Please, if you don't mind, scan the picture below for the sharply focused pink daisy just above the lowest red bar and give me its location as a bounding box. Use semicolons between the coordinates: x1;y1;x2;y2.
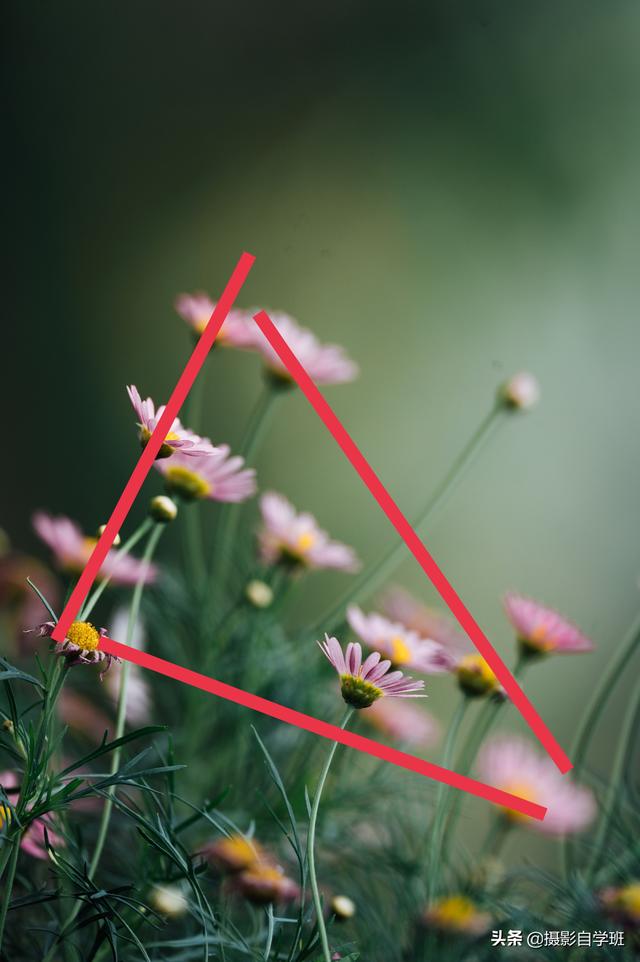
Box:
318;635;424;708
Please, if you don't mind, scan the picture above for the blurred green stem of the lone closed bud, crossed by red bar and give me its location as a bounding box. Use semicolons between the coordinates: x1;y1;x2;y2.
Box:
309;402;506;636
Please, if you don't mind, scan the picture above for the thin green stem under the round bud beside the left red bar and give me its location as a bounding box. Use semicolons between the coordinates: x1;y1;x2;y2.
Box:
50;524;165;948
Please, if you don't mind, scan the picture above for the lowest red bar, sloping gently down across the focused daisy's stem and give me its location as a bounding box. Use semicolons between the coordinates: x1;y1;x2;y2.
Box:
100;638;547;821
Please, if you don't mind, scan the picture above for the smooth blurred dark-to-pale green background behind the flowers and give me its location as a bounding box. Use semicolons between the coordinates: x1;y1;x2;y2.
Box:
5;0;640;852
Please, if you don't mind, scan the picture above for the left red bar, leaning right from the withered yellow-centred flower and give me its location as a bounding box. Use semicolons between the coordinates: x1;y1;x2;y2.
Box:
52;252;255;641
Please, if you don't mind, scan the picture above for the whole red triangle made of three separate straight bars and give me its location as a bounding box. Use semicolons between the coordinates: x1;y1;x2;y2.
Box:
52;252;572;820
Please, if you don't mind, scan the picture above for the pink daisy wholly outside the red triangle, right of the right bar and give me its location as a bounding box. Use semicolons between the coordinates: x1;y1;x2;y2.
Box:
504;593;594;655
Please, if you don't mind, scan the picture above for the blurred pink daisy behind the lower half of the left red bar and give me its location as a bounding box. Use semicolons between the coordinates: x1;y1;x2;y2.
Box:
33;511;158;585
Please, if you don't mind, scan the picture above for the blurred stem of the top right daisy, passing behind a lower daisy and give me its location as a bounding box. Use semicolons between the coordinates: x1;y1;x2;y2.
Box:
211;380;283;605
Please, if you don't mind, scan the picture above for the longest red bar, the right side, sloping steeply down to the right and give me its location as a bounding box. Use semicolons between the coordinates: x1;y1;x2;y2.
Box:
254;311;573;772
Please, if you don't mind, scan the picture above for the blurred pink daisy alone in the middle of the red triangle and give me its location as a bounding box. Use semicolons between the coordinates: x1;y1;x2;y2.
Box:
258;491;360;571
